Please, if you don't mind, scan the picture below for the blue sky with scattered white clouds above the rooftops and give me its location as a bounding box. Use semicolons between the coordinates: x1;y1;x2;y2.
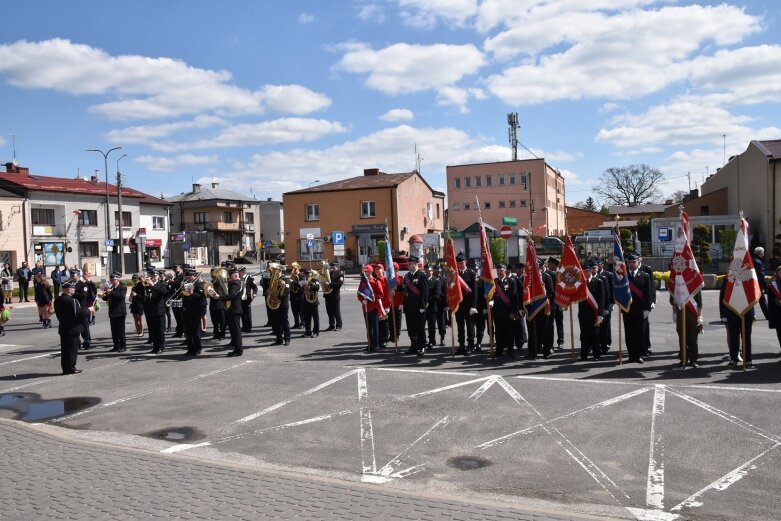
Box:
0;0;781;204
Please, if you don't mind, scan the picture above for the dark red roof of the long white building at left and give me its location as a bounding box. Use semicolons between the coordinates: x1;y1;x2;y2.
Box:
0;172;170;206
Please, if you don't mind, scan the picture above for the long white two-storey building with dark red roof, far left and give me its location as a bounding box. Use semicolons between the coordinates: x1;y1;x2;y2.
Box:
0;163;169;277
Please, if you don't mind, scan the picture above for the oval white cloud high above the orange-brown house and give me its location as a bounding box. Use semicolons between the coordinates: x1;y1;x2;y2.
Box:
335;43;485;95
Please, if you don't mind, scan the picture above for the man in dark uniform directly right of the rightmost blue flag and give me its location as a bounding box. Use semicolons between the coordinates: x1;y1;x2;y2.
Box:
621;253;653;364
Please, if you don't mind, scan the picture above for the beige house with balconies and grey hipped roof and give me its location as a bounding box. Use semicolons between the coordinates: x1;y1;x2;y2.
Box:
165;183;260;266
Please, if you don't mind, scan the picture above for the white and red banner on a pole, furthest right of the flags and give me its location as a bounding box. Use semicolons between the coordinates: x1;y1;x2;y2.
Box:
724;216;761;317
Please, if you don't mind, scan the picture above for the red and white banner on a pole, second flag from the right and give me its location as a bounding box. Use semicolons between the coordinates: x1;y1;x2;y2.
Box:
667;212;705;316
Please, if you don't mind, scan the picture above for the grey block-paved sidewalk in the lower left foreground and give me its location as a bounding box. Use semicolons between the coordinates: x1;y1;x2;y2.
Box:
0;419;620;521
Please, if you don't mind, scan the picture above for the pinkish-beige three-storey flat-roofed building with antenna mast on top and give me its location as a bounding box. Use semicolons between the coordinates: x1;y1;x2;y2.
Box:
447;159;567;236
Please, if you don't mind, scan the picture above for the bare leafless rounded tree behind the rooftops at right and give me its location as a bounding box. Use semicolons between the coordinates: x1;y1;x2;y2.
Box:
593;164;664;206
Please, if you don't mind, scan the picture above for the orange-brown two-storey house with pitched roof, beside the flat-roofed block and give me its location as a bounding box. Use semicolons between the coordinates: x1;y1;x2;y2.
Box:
282;168;445;267
